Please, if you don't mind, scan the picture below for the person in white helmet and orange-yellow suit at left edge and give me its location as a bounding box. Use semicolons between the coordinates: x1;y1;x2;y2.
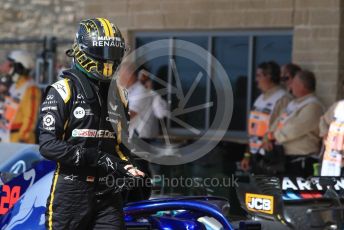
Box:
0;50;41;143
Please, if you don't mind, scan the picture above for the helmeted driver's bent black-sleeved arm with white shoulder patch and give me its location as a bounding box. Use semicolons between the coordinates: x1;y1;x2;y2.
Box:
39;80;98;166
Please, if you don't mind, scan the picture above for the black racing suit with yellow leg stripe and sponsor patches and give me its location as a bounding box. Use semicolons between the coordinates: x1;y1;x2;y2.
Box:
39;70;129;230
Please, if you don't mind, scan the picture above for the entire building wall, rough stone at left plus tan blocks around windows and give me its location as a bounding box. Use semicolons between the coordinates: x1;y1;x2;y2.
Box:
0;0;344;105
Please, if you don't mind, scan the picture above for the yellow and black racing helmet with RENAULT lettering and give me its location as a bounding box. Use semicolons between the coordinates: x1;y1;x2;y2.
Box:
67;18;126;81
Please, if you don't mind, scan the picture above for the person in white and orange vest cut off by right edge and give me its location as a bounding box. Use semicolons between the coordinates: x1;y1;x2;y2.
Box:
319;89;344;176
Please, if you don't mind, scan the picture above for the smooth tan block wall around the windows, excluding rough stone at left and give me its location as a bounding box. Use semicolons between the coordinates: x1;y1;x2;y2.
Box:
85;0;343;106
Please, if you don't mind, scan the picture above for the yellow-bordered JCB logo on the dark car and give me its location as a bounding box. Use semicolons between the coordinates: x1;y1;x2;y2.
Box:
245;193;274;214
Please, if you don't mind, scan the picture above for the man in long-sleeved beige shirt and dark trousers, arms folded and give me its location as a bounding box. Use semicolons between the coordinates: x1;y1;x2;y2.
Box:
266;70;323;177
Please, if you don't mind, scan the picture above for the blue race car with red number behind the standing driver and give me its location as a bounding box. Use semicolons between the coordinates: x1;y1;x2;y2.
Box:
0;145;260;230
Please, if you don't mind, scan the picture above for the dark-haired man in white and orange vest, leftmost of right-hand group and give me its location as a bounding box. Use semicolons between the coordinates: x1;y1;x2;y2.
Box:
241;61;290;171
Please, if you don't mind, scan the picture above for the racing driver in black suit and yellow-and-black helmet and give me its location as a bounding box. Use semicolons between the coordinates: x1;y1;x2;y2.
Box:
39;18;144;230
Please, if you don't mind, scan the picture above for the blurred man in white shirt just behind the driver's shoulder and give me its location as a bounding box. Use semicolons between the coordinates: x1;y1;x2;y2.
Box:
119;63;159;138
